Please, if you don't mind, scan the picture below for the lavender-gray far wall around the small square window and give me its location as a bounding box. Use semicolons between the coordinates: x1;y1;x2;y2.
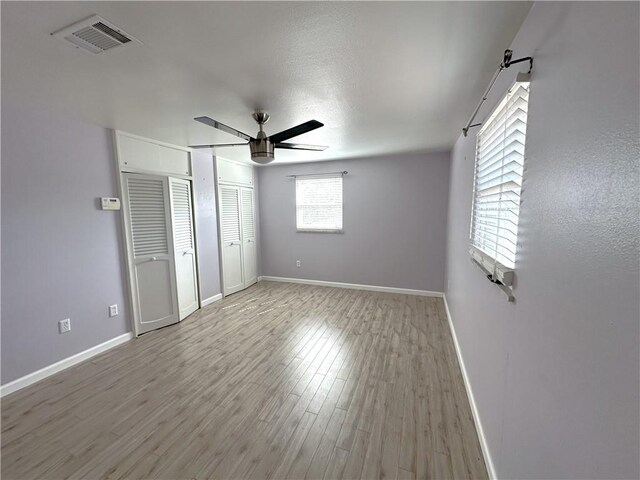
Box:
257;153;449;291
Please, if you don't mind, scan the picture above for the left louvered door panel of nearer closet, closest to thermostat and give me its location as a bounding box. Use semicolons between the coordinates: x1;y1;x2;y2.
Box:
123;174;178;335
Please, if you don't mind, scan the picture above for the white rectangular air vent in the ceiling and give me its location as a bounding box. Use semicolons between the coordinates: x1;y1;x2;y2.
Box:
51;15;141;53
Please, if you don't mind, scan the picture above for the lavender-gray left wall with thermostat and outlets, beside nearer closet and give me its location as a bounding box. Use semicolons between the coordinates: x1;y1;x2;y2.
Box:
1;100;131;384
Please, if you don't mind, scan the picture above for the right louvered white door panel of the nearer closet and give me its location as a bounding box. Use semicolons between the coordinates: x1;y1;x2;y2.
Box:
169;177;199;320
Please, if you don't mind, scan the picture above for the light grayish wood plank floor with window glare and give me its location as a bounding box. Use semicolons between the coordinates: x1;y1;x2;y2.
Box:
2;282;487;479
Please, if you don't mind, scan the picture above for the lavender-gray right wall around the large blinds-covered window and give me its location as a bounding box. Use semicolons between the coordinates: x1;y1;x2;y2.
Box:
446;2;640;479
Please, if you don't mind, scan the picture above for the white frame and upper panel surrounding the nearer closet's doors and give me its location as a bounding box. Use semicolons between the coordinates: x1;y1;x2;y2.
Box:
112;130;202;337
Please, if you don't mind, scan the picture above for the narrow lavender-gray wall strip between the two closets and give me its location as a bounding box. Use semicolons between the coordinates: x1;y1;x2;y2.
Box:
191;151;222;300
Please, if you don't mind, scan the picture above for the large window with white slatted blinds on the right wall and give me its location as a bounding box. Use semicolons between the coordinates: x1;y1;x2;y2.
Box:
471;82;529;272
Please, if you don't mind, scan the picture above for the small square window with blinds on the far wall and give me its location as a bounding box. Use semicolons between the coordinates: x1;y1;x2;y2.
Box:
296;174;342;232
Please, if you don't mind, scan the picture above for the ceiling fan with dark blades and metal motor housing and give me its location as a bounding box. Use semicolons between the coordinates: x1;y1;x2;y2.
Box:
191;111;327;164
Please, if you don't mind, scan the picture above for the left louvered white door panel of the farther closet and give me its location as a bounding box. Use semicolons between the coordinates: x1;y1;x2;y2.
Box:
219;185;244;295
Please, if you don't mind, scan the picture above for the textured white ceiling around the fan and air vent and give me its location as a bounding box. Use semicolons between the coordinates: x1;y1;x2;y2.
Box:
2;2;532;163
